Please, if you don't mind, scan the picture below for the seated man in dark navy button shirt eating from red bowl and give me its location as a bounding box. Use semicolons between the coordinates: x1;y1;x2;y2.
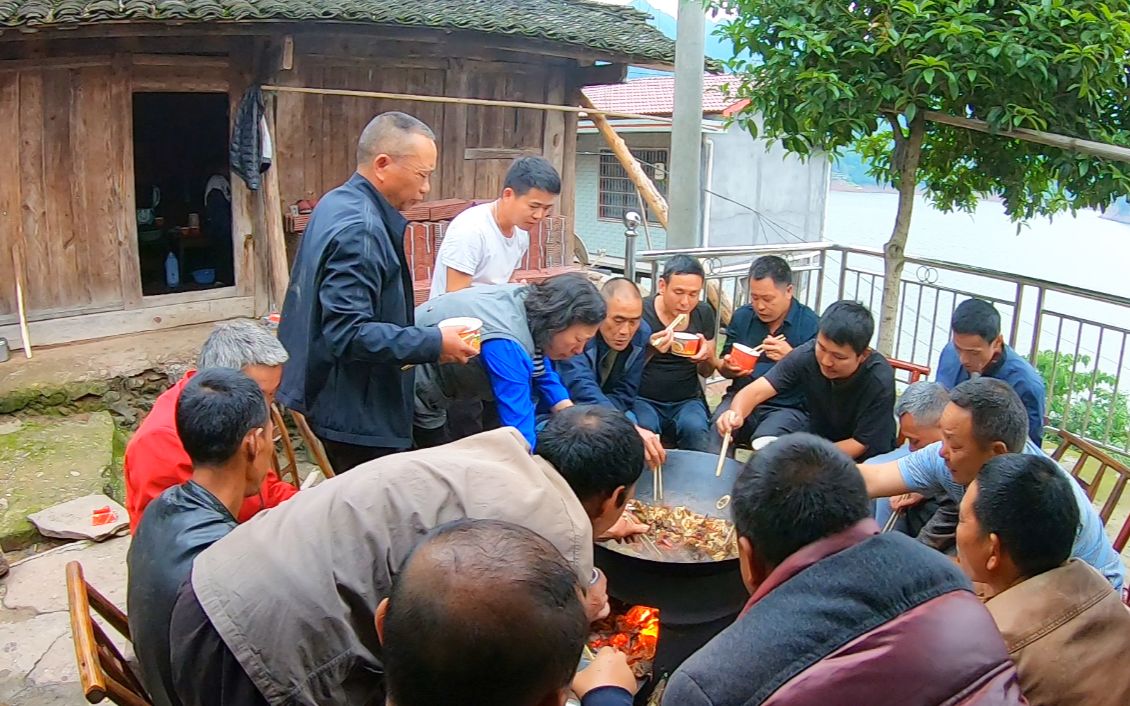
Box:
711;255;820;444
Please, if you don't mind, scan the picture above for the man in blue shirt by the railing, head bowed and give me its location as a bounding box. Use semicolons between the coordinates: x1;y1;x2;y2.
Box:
937;299;1046;445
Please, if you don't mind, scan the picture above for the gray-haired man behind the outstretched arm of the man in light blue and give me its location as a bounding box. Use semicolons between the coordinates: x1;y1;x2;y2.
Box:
868;381;957;552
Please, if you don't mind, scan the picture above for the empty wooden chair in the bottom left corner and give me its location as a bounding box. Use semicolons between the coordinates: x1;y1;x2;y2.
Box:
67;561;153;706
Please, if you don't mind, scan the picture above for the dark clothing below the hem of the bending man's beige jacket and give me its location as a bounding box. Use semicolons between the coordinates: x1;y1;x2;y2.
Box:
168;574;268;706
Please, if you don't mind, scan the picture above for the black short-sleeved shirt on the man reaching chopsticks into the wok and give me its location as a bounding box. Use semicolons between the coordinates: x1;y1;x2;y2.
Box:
765;340;897;459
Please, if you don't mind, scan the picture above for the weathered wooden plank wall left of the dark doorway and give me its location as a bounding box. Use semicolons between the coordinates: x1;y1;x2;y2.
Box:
0;59;133;322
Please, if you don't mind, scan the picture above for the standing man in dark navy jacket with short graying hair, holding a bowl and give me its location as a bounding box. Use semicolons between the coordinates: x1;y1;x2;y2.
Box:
278;113;475;473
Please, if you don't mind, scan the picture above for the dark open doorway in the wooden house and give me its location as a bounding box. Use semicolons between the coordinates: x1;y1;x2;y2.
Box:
133;93;235;296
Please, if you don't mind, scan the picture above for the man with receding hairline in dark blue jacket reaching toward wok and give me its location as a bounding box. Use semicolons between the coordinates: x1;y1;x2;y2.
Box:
557;277;667;467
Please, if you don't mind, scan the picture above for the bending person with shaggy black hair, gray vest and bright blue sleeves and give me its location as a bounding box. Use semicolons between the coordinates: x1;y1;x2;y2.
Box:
414;273;606;448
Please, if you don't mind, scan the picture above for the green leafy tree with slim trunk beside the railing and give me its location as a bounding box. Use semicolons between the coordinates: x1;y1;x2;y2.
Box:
707;0;1130;354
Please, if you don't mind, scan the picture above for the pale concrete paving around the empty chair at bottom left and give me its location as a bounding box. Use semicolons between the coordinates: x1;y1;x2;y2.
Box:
0;538;130;706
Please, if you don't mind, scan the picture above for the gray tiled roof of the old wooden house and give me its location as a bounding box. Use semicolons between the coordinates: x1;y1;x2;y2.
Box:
0;0;675;64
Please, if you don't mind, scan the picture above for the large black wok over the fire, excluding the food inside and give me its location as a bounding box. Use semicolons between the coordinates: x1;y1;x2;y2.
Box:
596;451;749;692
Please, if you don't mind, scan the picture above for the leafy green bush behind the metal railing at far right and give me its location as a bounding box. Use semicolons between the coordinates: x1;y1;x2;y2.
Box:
1036;350;1130;448
